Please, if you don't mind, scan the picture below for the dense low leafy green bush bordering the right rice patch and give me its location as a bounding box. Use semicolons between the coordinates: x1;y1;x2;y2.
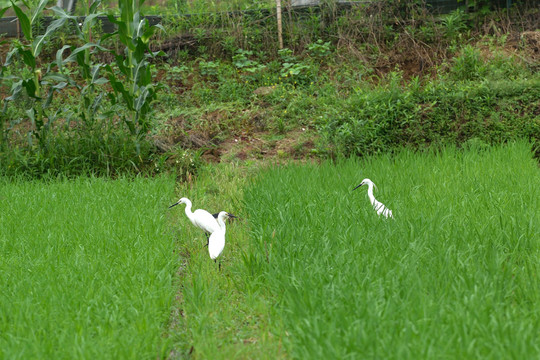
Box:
317;72;540;156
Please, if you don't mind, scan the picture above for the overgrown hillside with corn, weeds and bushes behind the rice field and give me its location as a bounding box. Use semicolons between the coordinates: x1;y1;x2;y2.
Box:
0;0;540;178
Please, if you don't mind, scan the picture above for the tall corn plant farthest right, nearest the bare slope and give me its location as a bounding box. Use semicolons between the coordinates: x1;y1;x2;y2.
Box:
105;0;164;139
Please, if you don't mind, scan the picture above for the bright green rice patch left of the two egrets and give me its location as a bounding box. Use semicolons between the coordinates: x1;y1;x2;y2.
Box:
0;177;177;359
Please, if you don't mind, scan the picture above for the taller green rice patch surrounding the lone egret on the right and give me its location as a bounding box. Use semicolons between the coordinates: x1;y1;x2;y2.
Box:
243;142;540;359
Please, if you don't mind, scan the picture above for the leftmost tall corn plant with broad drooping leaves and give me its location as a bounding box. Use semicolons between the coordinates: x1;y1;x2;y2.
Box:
0;0;68;149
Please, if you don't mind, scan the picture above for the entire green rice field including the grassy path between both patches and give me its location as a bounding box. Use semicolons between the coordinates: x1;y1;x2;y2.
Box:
0;142;540;359
